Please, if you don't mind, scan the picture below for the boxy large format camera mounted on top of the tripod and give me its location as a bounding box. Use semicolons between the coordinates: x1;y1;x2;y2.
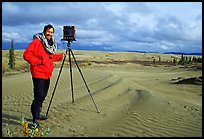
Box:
62;26;76;41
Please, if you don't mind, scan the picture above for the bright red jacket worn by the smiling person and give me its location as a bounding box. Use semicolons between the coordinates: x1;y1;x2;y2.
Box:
23;38;63;79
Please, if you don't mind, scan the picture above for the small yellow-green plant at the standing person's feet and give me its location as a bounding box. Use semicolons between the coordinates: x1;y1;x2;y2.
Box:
20;117;51;137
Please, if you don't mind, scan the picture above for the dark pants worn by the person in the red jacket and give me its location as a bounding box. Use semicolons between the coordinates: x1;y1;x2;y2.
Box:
31;77;50;121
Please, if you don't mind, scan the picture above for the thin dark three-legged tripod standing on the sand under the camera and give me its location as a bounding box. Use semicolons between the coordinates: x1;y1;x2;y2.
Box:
46;40;100;116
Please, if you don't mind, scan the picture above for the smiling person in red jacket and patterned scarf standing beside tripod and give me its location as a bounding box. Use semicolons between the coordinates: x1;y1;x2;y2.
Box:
23;24;65;128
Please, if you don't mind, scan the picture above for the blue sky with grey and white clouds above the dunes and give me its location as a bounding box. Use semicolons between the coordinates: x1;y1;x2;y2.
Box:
2;2;202;53
